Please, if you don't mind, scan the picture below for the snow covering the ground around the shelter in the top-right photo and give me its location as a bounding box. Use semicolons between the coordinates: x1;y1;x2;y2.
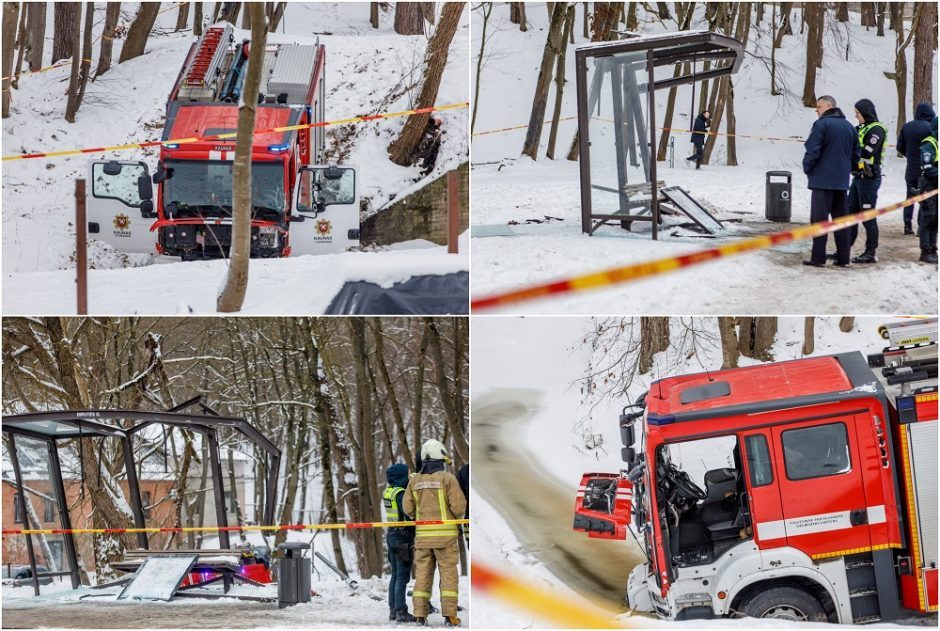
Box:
471;5;937;314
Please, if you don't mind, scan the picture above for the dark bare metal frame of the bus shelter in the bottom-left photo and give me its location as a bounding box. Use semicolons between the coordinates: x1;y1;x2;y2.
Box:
2;404;281;596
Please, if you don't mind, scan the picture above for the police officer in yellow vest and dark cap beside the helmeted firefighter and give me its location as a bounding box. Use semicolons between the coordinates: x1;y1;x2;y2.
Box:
382;463;415;622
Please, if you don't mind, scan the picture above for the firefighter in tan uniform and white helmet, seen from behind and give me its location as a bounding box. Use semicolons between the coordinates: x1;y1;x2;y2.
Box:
403;439;467;626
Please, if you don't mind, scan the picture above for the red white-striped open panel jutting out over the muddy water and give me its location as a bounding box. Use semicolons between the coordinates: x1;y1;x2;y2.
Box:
573;473;633;539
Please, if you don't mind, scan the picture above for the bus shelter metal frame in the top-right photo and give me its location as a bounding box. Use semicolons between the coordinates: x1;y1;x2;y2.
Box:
575;31;744;240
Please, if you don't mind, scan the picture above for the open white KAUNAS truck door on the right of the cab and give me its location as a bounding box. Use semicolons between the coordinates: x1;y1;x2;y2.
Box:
290;165;359;255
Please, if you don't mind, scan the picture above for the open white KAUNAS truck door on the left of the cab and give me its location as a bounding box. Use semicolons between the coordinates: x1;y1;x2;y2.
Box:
85;160;157;254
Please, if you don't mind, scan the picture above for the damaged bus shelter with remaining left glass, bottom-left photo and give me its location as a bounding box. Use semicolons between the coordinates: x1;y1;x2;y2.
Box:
2;404;281;596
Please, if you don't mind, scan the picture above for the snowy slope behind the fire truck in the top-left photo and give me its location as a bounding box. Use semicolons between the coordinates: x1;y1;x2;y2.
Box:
2;3;469;311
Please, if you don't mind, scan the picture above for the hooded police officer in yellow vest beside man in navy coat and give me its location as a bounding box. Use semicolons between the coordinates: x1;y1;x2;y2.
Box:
849;99;888;263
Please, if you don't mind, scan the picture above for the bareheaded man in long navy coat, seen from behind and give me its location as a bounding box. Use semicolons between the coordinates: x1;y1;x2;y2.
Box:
803;95;861;267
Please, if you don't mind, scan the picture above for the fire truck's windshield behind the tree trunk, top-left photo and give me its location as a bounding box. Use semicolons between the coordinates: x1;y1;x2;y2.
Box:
163;160;287;219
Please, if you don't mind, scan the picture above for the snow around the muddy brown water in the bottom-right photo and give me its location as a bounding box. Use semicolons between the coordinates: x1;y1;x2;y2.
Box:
470;317;936;629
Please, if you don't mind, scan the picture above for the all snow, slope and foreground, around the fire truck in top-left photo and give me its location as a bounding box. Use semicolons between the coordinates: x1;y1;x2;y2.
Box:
2;2;470;313
